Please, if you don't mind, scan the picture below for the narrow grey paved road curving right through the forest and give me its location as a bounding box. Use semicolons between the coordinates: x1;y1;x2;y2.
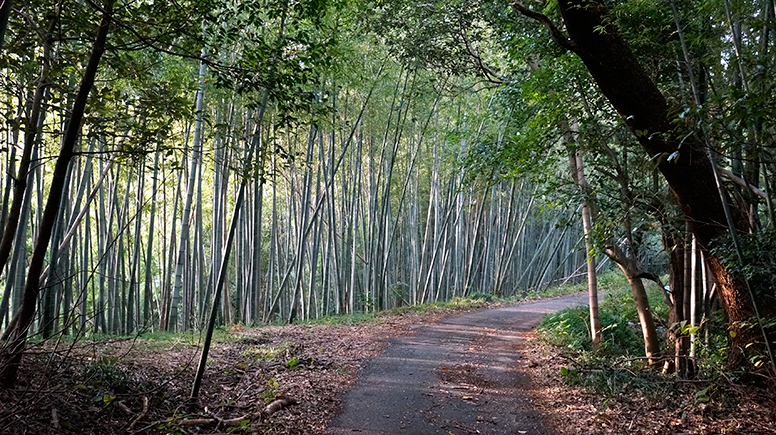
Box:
329;294;587;435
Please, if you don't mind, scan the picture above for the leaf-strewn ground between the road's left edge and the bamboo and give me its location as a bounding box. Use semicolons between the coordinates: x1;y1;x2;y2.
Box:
0;309;451;434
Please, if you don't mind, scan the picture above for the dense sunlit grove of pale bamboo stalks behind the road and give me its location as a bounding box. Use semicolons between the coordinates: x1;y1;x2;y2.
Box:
0;0;584;346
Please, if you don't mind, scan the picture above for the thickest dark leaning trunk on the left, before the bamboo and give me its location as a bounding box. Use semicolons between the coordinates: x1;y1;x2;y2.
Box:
0;3;112;387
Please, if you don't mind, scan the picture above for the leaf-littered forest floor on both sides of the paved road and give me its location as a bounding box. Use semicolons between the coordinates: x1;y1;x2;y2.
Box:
0;296;776;435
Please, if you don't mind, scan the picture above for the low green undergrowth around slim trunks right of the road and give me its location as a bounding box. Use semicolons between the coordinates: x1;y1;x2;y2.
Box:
537;272;744;402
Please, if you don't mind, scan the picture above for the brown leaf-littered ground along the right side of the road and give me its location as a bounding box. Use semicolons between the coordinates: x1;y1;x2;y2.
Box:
524;333;776;435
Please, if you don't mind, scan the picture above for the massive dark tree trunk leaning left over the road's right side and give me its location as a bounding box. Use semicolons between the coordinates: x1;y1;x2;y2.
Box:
515;0;776;366
